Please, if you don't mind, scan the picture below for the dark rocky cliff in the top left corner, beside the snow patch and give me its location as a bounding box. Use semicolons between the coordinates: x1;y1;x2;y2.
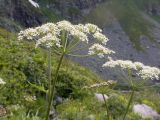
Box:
0;0;45;29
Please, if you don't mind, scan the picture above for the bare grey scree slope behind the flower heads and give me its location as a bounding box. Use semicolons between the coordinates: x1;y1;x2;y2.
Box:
72;19;160;80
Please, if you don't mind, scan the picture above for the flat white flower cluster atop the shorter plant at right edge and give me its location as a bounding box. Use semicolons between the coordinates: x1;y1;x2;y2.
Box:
103;60;160;80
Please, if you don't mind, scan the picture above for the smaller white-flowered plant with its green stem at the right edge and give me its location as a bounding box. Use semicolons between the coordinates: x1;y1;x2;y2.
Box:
102;59;160;120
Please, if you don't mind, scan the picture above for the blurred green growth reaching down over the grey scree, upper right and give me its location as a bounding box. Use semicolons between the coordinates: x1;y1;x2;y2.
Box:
85;0;158;50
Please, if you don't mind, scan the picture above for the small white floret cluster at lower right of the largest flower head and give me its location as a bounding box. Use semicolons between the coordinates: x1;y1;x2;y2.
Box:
88;43;115;58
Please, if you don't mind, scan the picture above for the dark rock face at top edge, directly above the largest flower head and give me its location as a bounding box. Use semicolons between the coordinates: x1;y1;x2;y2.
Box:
43;0;104;22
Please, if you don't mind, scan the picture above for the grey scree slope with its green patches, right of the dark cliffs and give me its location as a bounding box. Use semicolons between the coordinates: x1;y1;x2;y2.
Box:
73;0;160;79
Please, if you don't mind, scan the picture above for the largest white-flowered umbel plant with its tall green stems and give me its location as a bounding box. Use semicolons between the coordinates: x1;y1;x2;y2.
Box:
18;21;114;120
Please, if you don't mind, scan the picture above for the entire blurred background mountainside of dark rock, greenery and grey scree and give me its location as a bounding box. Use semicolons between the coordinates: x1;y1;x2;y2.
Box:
0;0;160;79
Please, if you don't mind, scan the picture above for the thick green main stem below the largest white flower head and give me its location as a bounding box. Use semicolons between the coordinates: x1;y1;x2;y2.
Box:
46;52;65;120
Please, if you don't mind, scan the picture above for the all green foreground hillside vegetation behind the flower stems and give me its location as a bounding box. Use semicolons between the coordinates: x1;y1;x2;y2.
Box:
0;25;160;120
